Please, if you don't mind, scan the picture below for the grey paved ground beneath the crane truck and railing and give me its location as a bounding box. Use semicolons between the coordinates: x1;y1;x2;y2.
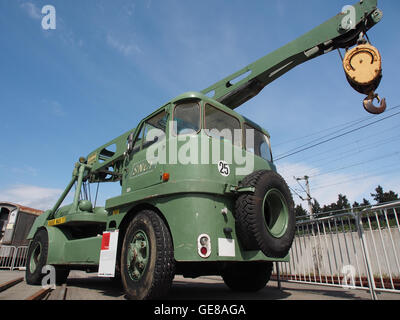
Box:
0;270;400;300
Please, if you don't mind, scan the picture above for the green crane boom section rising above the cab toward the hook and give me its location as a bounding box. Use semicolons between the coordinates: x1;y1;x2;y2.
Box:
202;0;382;109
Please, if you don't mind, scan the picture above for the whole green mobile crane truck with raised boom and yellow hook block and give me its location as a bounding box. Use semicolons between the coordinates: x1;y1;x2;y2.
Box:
26;0;386;299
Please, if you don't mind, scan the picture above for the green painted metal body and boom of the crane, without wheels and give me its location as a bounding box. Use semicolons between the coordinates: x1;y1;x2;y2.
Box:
28;0;381;266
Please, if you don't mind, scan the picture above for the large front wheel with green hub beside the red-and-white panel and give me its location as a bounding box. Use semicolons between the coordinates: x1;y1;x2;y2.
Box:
121;210;175;300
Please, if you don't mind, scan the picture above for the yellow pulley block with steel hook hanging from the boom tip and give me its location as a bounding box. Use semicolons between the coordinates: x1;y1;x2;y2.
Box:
343;41;386;114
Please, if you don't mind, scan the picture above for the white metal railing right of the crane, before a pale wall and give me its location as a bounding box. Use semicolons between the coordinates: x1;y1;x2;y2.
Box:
274;201;400;299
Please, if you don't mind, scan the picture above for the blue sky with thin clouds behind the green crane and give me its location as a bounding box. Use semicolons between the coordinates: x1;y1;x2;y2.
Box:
0;0;400;209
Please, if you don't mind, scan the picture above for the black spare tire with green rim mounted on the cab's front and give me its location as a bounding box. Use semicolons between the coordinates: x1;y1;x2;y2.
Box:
235;170;296;258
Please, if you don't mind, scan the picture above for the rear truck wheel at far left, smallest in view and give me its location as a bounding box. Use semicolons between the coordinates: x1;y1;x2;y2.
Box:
25;230;49;285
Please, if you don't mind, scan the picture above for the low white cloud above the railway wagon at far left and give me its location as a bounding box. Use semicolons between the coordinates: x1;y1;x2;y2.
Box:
0;185;63;210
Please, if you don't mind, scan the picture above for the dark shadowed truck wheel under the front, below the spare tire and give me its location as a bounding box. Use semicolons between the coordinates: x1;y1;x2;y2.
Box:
222;262;272;292
